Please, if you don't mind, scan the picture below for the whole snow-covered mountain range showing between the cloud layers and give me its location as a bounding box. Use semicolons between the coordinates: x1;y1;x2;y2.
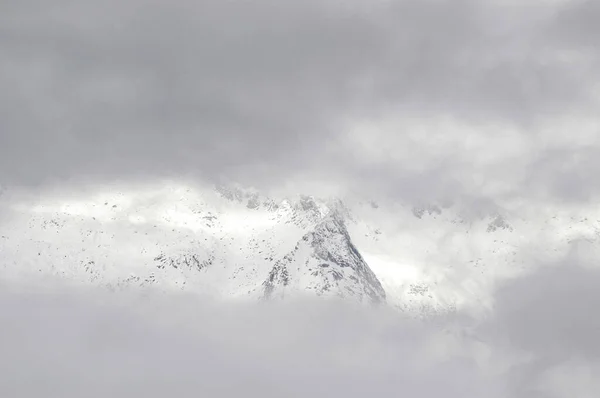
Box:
0;183;600;313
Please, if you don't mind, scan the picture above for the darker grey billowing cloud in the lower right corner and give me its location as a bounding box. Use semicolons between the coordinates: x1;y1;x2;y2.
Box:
480;255;600;398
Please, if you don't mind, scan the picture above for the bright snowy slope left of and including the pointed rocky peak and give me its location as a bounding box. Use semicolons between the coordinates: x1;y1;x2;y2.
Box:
0;185;385;302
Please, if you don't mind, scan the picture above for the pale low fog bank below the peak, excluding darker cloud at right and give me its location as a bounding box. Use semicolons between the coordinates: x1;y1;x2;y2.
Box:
0;285;502;398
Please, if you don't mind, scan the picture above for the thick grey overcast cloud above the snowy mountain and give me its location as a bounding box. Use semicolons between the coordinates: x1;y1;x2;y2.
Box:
0;0;600;202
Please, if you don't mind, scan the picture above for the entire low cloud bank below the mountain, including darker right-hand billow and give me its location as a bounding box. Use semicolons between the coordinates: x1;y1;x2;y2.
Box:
0;258;600;398
